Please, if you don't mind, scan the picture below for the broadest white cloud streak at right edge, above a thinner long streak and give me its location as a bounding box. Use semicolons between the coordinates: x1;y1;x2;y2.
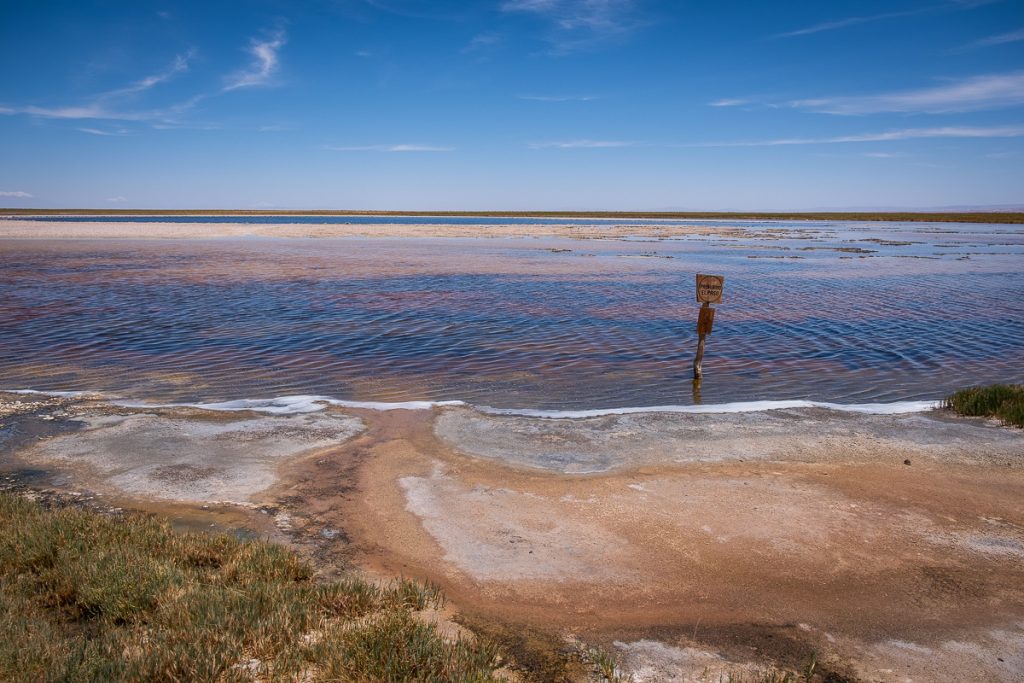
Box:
790;72;1024;116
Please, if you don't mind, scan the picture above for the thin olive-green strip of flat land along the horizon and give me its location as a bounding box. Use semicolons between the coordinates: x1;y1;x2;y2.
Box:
0;208;1024;223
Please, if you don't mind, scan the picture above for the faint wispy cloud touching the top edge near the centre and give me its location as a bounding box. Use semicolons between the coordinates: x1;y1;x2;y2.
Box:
501;0;643;54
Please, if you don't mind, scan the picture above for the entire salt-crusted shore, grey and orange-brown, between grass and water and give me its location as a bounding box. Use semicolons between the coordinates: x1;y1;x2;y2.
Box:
0;394;1024;681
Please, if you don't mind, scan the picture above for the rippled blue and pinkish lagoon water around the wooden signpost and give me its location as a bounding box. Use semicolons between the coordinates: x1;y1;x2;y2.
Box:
0;217;1024;410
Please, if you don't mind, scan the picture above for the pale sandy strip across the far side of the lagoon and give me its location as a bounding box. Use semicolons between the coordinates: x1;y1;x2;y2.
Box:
0;218;757;240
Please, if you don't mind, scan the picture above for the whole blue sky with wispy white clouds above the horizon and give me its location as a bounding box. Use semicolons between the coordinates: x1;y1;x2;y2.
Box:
0;0;1024;210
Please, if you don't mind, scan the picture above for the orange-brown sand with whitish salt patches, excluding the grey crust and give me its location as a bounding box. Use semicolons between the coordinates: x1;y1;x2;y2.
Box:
276;413;1024;681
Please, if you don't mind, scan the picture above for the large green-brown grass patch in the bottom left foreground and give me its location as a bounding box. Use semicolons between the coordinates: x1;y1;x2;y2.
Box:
0;495;497;681
